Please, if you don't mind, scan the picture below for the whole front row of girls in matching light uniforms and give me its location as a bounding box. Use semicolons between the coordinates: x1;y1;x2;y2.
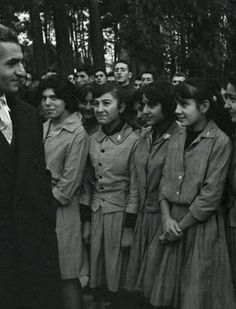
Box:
36;74;236;309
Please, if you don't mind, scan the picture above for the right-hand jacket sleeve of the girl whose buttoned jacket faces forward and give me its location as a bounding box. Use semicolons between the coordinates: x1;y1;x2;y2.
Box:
125;140;139;214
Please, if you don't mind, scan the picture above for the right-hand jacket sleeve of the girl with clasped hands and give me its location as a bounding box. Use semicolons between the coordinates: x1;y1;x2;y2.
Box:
189;136;232;221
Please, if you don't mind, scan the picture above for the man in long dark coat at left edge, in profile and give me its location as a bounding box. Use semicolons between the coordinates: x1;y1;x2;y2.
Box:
0;25;60;309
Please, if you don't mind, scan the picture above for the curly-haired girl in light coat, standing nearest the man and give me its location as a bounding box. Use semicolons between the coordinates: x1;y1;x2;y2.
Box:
39;76;88;309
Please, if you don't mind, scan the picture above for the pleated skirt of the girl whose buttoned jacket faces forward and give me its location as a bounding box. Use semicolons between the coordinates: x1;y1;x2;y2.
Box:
90;208;129;292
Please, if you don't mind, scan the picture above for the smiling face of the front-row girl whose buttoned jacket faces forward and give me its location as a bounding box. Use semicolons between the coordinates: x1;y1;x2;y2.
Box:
93;93;124;125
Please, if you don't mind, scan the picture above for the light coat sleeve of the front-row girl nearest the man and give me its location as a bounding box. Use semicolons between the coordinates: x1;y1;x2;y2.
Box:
53;132;89;205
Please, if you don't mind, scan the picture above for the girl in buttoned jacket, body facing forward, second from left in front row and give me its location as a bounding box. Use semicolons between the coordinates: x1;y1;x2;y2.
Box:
83;84;138;305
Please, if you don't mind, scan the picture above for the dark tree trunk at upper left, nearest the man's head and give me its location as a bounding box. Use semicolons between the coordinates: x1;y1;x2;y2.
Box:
30;0;46;76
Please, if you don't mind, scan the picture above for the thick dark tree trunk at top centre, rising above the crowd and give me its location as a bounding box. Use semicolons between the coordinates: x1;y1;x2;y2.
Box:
89;0;105;70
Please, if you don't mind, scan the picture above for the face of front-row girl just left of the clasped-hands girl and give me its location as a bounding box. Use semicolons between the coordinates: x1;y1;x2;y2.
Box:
142;94;165;126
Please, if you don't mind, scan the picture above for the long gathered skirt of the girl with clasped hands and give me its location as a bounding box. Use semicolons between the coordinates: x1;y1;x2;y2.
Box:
136;205;236;309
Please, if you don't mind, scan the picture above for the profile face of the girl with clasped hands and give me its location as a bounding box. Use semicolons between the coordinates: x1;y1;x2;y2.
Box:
175;99;203;127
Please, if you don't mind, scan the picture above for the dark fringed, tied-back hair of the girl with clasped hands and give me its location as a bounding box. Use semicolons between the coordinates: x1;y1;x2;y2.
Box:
173;78;232;135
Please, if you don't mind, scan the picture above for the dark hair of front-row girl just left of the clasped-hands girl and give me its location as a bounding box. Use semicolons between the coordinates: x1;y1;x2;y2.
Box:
140;81;176;120
